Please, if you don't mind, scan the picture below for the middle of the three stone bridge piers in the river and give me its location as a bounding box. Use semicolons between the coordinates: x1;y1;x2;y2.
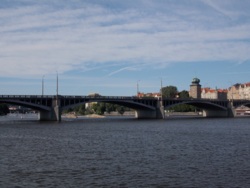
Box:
135;102;165;119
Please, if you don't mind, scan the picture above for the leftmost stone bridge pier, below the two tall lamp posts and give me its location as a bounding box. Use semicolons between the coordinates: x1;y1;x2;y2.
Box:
39;99;61;121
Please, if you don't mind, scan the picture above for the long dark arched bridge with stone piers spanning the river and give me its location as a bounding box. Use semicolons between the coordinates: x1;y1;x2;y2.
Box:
0;95;250;121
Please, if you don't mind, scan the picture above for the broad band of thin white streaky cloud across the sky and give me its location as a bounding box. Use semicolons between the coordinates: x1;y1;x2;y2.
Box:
0;0;250;77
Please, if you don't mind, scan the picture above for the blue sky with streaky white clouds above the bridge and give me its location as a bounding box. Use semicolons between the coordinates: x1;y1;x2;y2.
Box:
0;0;250;96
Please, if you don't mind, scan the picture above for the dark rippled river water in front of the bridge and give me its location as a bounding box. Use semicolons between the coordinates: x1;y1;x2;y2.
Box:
0;117;250;188
